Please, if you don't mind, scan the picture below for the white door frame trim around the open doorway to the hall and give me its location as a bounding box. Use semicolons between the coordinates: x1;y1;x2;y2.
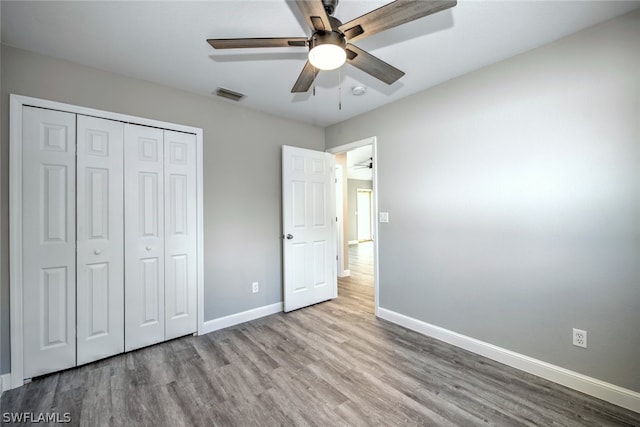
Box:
325;136;380;317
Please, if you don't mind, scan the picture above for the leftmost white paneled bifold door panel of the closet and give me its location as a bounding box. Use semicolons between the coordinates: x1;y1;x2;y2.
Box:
22;107;76;378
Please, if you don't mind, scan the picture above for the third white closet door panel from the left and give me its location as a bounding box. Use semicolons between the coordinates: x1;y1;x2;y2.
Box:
124;124;164;351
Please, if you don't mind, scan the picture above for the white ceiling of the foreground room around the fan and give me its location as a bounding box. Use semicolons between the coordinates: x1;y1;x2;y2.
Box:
2;0;640;126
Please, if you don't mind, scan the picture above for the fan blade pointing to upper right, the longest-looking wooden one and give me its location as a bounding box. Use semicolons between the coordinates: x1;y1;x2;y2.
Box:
340;0;457;42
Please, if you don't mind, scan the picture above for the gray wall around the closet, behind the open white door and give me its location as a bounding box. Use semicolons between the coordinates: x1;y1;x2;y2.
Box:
0;46;324;373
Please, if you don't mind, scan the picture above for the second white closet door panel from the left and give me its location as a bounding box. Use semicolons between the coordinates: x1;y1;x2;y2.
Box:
76;116;124;364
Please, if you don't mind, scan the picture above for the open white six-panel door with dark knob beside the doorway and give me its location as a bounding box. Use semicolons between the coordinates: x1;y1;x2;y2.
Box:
282;146;338;311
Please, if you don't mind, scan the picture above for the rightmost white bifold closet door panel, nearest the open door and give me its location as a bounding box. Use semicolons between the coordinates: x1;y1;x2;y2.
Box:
164;131;197;339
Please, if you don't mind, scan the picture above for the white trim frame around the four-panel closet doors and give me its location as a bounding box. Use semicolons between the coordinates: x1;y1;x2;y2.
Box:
9;94;206;388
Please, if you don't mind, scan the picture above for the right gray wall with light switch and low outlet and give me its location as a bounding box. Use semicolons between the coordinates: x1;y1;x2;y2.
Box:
326;11;640;391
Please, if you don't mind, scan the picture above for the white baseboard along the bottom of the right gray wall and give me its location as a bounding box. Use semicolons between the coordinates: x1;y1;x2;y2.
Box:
377;307;640;413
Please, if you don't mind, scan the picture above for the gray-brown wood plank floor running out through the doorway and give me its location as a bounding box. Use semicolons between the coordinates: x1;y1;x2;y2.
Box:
0;245;640;426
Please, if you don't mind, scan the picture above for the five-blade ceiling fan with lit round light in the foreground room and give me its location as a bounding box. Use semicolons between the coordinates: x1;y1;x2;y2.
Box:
207;0;457;93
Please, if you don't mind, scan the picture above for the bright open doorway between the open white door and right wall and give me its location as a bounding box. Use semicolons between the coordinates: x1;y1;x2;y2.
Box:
327;137;378;315
